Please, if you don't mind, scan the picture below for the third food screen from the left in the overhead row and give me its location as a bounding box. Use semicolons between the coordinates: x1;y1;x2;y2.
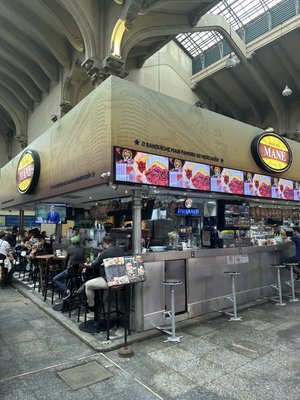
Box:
210;166;244;194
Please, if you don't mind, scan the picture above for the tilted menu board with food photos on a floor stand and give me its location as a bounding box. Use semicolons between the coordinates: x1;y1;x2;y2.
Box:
103;256;146;287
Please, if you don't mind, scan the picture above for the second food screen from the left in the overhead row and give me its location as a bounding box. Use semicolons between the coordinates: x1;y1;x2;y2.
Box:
169;158;210;191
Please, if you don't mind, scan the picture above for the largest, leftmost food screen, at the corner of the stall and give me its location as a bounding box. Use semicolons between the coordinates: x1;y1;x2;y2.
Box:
115;147;169;186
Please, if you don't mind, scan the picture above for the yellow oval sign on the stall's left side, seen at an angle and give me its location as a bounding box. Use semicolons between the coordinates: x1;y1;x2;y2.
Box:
16;150;40;194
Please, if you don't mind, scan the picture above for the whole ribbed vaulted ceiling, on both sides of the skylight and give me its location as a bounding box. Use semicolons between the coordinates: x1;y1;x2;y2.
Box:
0;0;300;159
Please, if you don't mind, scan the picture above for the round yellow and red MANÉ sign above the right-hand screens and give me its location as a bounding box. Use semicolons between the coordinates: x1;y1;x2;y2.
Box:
251;132;292;172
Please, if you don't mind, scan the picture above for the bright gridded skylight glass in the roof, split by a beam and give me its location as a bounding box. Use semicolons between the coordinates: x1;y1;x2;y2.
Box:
176;0;285;57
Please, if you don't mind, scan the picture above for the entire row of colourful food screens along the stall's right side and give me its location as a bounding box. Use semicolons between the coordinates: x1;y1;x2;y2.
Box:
114;147;300;201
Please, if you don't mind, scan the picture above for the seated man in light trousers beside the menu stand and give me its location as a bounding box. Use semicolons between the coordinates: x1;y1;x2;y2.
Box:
85;235;125;311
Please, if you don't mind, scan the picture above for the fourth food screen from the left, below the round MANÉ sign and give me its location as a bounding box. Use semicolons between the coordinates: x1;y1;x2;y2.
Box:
244;172;271;198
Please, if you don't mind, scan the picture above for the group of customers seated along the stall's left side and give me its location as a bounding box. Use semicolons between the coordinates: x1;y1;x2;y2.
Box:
0;227;125;310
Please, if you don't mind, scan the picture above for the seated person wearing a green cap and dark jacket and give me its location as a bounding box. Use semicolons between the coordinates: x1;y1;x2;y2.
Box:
53;236;85;300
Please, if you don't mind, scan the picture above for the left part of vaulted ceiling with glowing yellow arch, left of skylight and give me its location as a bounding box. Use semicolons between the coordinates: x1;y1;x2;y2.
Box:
0;0;215;152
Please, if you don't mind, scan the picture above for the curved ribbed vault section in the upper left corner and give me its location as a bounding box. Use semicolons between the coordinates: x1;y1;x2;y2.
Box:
0;0;84;148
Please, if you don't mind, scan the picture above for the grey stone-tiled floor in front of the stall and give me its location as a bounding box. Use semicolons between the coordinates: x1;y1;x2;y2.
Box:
0;276;300;400
